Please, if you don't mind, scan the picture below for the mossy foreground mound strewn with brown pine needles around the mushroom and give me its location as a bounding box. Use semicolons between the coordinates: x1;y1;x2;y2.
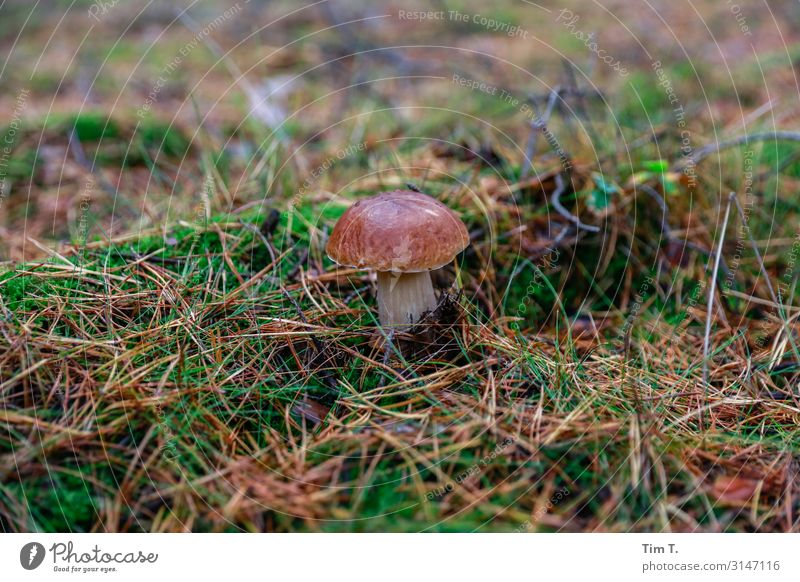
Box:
0;179;798;531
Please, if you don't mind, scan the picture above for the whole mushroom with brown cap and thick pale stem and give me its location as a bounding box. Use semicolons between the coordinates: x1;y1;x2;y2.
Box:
325;190;469;330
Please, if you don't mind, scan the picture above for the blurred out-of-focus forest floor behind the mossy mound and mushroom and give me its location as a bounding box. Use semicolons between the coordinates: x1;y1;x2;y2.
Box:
0;0;800;260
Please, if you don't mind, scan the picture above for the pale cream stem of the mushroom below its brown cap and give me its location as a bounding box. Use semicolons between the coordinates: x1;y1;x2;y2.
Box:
378;271;436;330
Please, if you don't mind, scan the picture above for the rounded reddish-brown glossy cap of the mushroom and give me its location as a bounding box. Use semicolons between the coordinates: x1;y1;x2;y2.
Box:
325;190;469;273
